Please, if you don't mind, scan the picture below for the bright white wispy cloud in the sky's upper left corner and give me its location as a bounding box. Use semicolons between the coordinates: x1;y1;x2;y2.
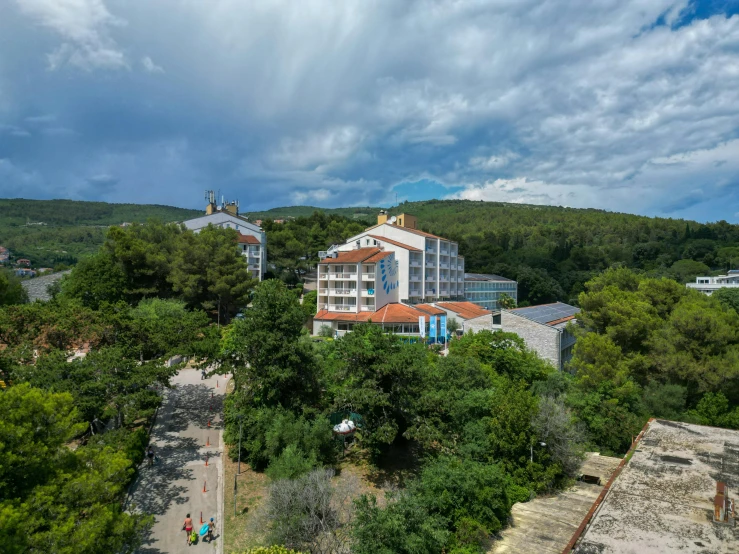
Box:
16;0;128;71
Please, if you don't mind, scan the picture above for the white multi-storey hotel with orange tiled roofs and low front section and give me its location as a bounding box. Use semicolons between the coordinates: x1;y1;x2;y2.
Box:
313;212;482;336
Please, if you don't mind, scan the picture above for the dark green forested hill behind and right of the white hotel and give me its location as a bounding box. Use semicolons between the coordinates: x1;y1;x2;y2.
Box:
262;200;739;304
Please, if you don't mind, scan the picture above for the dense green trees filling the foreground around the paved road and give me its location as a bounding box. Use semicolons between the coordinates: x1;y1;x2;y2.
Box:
0;214;739;554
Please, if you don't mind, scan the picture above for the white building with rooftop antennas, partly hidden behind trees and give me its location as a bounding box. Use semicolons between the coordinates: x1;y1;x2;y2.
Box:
182;191;267;281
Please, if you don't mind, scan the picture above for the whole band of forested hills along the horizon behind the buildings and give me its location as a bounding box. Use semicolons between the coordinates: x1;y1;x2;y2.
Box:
5;196;739;305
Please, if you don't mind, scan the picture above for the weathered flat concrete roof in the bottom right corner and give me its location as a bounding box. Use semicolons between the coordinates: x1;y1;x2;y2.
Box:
565;419;739;554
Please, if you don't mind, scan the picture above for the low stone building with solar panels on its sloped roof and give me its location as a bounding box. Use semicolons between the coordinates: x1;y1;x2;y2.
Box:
501;302;580;370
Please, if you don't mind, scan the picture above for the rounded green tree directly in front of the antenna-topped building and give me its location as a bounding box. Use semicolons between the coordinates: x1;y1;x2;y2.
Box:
169;225;257;323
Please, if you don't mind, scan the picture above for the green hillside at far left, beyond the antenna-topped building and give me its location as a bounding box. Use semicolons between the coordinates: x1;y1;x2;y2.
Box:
0;198;202;267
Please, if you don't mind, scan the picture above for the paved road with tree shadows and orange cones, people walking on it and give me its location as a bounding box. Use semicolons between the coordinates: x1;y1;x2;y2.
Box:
128;369;226;554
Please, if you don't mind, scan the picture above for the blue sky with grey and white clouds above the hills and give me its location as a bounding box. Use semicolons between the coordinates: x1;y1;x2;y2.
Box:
0;0;739;223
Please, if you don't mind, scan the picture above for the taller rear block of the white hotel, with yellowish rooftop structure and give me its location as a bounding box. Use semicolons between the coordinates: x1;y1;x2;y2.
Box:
334;212;464;304
